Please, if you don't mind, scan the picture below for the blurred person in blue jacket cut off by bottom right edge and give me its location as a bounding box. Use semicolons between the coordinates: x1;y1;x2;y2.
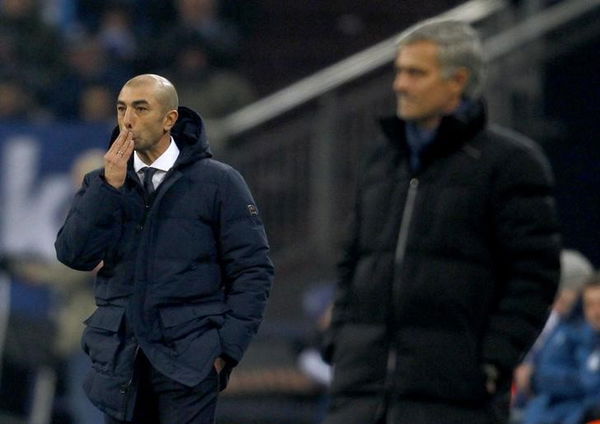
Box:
523;274;600;424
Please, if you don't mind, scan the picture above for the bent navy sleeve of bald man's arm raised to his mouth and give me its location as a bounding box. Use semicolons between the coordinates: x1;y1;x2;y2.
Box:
54;171;122;271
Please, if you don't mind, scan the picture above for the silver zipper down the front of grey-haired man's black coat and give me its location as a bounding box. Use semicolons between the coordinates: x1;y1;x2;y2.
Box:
377;177;419;422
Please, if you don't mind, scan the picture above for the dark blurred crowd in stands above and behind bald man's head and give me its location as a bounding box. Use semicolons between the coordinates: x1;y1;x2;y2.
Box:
0;0;257;122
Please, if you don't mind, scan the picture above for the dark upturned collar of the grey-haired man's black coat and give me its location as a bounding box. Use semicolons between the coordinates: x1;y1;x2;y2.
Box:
380;99;487;162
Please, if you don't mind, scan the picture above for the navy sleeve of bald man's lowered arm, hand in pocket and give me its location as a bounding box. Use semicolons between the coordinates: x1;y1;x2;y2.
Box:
218;169;273;365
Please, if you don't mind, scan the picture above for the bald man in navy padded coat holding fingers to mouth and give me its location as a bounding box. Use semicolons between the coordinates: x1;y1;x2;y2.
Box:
56;74;273;424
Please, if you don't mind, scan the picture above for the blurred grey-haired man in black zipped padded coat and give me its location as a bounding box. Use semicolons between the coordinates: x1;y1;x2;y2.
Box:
324;20;560;424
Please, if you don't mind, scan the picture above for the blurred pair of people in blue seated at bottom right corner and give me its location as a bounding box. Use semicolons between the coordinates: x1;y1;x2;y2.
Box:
511;249;600;424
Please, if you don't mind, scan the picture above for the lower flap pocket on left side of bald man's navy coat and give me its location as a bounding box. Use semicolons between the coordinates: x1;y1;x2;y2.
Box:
82;306;125;373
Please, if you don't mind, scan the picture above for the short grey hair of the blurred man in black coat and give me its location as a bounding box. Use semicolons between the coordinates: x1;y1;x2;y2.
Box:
396;18;485;99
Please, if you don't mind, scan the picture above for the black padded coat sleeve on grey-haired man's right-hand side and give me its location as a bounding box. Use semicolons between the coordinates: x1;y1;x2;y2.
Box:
482;142;560;378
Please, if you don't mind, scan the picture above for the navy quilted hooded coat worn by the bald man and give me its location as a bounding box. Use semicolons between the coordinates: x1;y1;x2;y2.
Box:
55;107;273;420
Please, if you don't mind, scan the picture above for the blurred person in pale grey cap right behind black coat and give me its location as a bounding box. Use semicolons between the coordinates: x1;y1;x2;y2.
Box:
511;249;593;421
